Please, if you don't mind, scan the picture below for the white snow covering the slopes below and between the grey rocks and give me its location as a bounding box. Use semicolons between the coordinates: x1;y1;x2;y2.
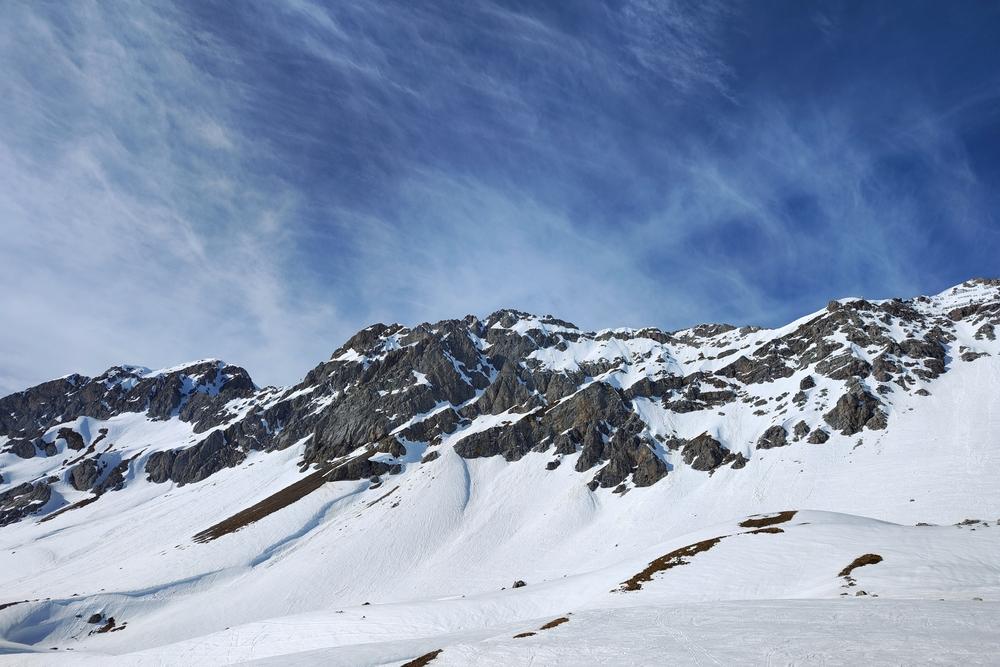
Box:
0;285;1000;667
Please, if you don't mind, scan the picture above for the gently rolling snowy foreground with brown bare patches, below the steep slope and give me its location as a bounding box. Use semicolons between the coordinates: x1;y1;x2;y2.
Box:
0;511;1000;665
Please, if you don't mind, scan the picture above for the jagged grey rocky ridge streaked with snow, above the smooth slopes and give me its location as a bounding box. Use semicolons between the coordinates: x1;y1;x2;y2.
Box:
0;279;1000;524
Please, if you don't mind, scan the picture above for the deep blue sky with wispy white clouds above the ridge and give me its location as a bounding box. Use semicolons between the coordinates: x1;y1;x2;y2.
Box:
0;0;1000;394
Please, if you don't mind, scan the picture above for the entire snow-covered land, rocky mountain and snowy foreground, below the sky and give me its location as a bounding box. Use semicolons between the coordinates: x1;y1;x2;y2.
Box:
0;279;1000;665
